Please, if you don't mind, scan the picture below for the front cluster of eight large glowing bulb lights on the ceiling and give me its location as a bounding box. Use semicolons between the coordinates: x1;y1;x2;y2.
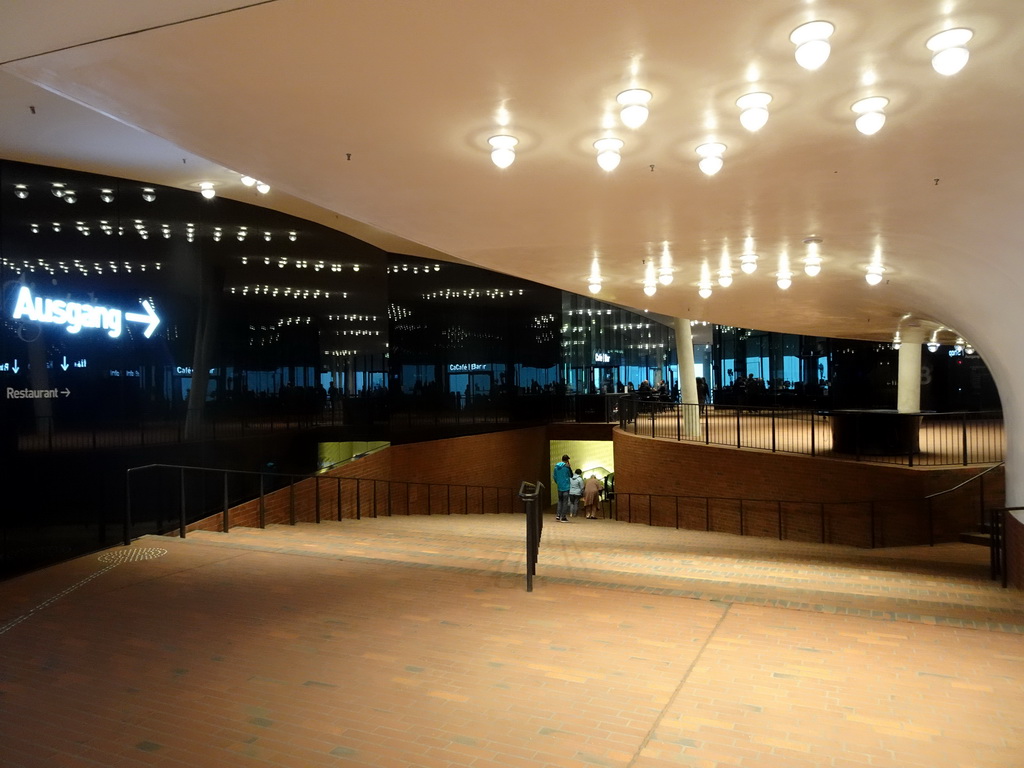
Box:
487;20;974;176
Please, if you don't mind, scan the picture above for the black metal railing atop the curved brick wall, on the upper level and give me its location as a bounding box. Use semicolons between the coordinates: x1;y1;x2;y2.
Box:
618;397;1006;467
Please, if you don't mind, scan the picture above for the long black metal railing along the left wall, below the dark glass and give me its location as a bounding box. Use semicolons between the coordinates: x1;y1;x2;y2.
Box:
123;464;515;544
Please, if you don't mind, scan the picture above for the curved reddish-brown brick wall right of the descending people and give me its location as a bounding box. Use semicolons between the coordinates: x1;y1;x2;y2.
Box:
613;429;1005;547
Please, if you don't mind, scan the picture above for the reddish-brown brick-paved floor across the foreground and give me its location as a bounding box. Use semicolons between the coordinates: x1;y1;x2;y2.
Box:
0;515;1024;768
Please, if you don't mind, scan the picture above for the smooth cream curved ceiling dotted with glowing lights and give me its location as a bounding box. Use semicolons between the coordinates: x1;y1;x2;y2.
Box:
0;0;1024;348
